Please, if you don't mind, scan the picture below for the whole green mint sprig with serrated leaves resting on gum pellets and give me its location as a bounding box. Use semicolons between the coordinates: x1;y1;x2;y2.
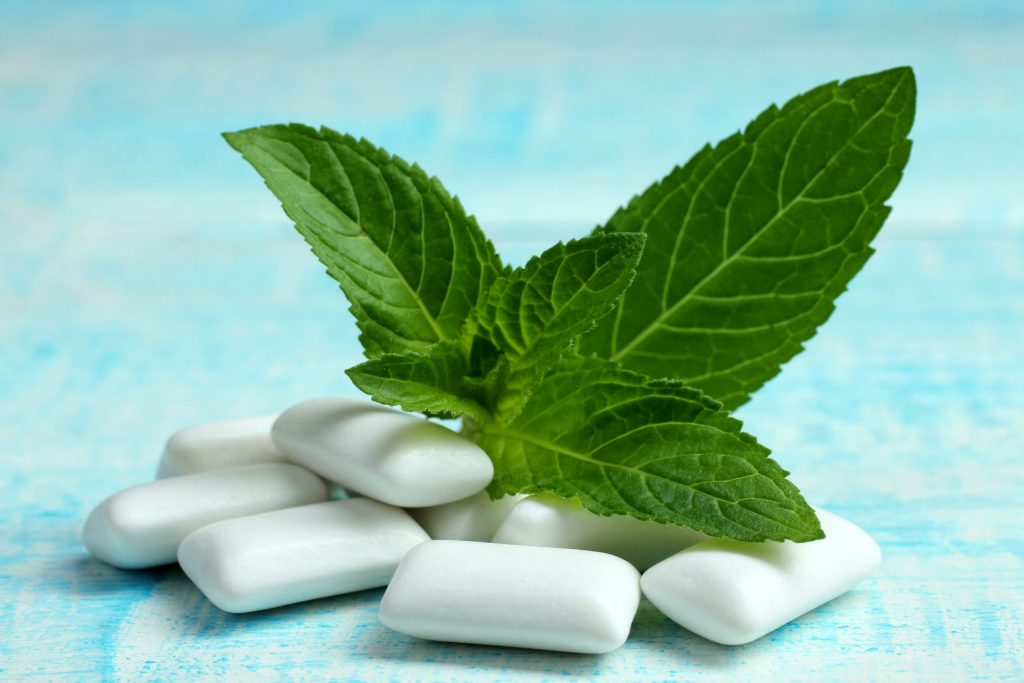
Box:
225;68;915;542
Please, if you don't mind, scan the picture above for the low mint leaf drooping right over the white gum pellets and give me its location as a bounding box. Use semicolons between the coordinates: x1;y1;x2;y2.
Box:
477;357;823;542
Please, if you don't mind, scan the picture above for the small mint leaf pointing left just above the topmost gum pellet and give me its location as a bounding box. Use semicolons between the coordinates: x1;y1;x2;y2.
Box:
345;341;489;422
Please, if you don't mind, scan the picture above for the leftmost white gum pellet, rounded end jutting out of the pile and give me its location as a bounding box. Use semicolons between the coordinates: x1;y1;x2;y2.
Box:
82;463;328;569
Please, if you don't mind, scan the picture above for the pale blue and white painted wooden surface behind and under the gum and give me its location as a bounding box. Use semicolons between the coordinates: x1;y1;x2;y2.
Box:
0;2;1024;681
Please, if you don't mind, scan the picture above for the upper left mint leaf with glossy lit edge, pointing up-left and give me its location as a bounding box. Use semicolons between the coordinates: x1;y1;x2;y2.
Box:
224;124;502;357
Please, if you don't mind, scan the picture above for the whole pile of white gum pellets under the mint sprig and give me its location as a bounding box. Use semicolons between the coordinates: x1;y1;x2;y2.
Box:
82;398;881;653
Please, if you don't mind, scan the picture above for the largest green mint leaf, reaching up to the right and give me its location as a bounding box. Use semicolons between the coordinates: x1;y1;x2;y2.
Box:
581;68;915;410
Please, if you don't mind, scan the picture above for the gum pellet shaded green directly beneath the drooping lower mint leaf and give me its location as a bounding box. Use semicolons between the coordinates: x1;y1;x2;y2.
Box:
494;495;708;571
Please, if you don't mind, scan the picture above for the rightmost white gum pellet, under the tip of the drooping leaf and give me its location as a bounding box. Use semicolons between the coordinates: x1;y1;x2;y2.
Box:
641;510;882;645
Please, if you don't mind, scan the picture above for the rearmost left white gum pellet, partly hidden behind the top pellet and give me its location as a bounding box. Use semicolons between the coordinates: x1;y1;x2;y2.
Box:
157;415;285;479
